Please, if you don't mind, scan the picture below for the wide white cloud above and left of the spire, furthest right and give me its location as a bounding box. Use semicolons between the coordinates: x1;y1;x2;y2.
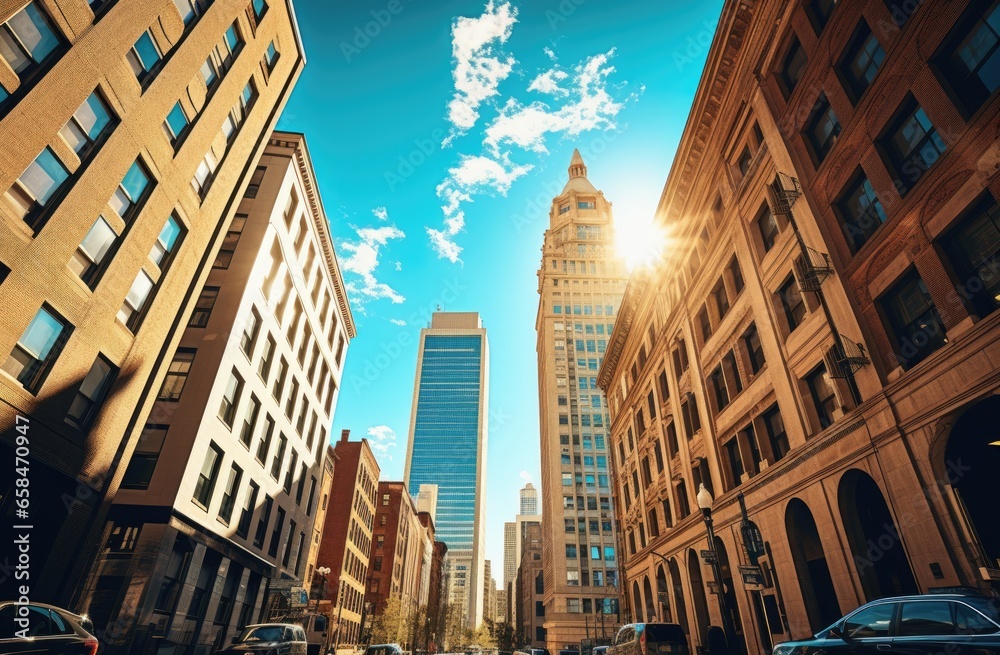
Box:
483;49;626;153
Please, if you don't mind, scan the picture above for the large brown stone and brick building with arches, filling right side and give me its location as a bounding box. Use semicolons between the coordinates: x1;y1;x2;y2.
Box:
600;0;1000;653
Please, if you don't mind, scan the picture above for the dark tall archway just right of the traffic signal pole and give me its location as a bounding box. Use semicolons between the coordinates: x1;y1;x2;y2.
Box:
785;498;842;633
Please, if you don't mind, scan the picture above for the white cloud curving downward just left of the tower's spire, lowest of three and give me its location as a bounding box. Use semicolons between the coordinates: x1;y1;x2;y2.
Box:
427;153;532;264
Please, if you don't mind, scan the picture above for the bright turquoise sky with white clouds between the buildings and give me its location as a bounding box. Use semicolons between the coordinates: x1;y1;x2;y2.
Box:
278;0;722;581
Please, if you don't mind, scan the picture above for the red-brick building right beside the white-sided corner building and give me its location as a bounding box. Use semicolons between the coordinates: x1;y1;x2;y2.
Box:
313;430;380;645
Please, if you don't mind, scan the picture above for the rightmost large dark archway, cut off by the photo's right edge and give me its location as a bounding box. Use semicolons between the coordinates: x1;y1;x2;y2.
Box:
939;396;1000;568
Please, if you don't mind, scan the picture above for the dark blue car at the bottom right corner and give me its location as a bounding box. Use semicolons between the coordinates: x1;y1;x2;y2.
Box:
772;592;1000;655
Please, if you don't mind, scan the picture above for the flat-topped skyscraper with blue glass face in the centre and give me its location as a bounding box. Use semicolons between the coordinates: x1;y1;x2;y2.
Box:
404;312;489;629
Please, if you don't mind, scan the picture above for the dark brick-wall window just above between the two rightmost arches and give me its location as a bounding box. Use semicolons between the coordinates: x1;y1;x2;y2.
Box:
881;270;948;370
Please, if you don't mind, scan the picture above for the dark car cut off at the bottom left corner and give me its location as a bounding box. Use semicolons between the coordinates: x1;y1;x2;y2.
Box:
0;601;99;655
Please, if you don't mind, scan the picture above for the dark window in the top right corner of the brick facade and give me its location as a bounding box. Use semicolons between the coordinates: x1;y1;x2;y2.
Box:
936;0;1000;117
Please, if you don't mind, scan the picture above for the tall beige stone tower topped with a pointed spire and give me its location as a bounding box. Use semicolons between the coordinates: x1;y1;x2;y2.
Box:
526;150;627;652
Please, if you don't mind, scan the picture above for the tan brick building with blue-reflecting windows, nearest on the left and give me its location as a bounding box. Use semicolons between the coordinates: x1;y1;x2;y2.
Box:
0;0;304;609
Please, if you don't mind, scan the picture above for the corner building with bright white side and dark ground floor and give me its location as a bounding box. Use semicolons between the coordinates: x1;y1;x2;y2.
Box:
81;132;354;651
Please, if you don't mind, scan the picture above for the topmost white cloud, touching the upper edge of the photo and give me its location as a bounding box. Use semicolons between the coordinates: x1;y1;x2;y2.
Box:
446;0;517;137
